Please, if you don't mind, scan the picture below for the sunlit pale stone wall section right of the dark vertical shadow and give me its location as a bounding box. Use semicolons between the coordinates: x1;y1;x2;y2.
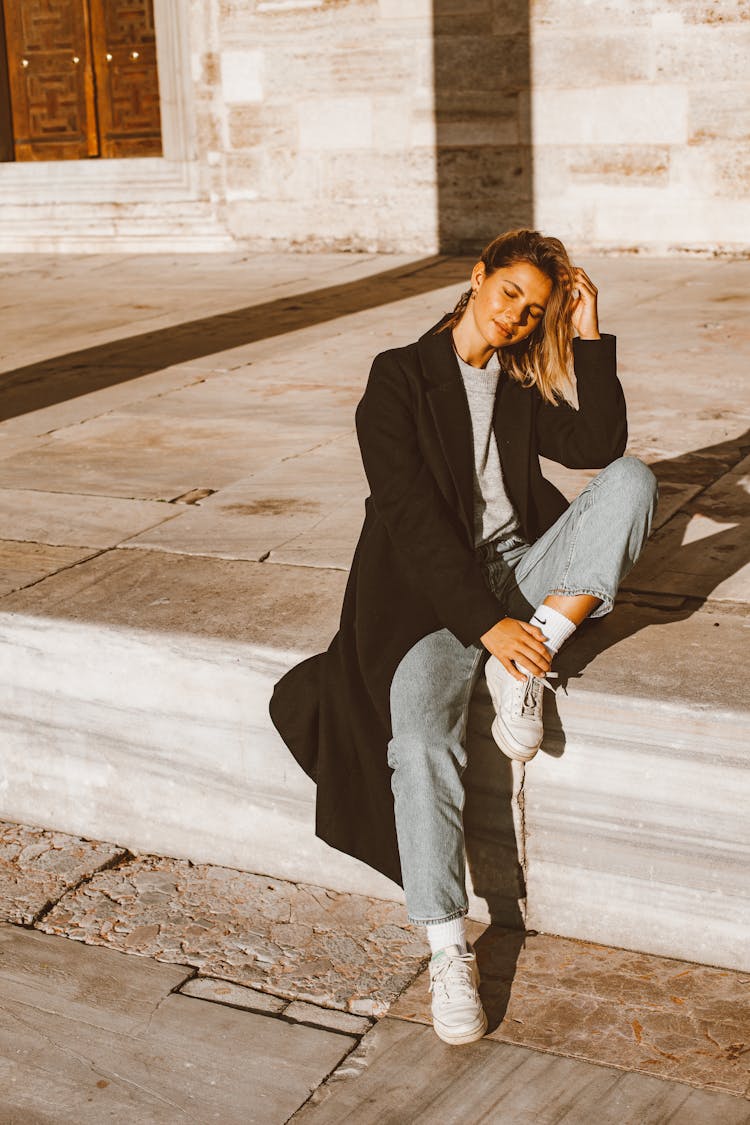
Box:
530;0;750;253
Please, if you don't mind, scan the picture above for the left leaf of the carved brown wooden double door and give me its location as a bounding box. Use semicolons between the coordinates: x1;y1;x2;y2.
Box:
4;0;99;160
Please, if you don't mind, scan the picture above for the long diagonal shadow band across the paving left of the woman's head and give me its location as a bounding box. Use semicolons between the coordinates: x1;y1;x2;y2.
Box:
0;255;466;421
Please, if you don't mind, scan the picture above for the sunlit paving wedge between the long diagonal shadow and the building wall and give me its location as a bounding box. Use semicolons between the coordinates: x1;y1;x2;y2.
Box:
0;252;416;370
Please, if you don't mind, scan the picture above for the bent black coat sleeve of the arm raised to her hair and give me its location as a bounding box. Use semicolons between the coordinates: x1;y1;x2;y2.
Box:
536;335;627;469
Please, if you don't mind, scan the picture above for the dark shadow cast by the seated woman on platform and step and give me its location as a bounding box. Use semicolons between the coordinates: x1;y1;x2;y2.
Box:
464;431;750;1031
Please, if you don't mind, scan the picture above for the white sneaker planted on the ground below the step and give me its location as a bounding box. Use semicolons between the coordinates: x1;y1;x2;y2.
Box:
430;945;487;1045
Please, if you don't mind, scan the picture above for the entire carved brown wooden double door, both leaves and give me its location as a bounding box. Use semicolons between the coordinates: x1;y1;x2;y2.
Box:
0;0;162;160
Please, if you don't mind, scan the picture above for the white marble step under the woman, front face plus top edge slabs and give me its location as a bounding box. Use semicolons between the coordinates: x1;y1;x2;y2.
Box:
0;549;750;970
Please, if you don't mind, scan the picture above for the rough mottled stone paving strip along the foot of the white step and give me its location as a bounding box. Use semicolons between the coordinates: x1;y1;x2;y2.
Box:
0;824;750;1102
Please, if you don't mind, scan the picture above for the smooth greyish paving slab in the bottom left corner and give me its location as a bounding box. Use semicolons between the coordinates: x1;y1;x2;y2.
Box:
0;927;356;1125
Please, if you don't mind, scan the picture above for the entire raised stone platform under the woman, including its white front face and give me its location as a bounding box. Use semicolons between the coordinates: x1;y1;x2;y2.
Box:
0;254;750;968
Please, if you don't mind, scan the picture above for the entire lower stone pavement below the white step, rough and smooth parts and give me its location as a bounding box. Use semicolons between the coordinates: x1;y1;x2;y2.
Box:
0;824;750;1125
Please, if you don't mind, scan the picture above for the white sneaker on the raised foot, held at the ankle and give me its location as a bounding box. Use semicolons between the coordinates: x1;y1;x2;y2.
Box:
485;656;554;762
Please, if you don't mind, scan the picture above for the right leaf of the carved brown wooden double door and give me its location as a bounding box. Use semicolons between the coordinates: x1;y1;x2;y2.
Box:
90;0;162;156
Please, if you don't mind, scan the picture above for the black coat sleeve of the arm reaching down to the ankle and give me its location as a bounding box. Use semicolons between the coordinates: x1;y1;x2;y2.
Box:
355;353;503;646
